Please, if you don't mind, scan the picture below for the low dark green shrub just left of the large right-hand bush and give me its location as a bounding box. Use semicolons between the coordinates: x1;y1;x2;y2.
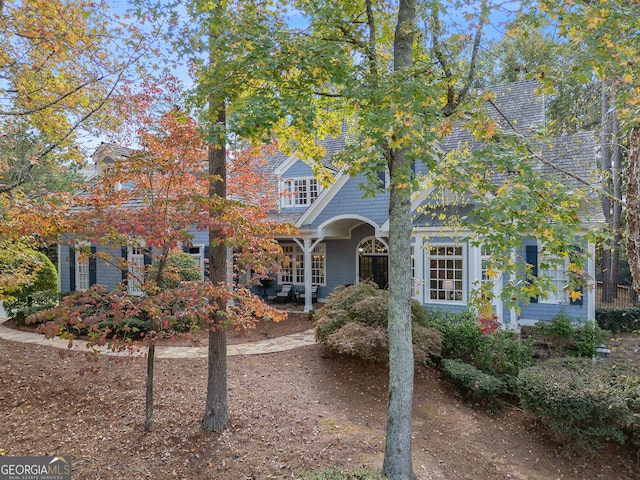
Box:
442;358;505;409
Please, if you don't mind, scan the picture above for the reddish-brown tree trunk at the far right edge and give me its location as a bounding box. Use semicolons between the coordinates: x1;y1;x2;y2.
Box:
627;125;640;300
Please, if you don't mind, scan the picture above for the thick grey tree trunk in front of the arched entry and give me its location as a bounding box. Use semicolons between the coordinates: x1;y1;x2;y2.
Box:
382;0;416;480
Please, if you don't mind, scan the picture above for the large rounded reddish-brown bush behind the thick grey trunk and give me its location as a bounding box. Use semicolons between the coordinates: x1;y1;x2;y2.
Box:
316;282;441;364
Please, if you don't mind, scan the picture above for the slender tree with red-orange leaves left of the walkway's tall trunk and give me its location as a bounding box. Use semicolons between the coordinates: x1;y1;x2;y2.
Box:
28;80;286;430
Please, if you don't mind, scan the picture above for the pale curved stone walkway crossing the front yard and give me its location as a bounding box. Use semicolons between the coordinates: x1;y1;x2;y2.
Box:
0;319;316;358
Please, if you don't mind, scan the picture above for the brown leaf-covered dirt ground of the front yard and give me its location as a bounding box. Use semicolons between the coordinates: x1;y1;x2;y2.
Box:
0;308;640;480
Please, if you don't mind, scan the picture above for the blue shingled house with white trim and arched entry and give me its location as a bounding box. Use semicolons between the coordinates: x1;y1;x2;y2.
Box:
59;81;602;327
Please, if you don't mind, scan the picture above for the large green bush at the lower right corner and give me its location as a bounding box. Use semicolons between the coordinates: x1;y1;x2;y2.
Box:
517;358;640;455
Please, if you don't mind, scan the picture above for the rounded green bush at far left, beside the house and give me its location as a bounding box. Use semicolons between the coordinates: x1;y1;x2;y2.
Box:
4;250;58;322
